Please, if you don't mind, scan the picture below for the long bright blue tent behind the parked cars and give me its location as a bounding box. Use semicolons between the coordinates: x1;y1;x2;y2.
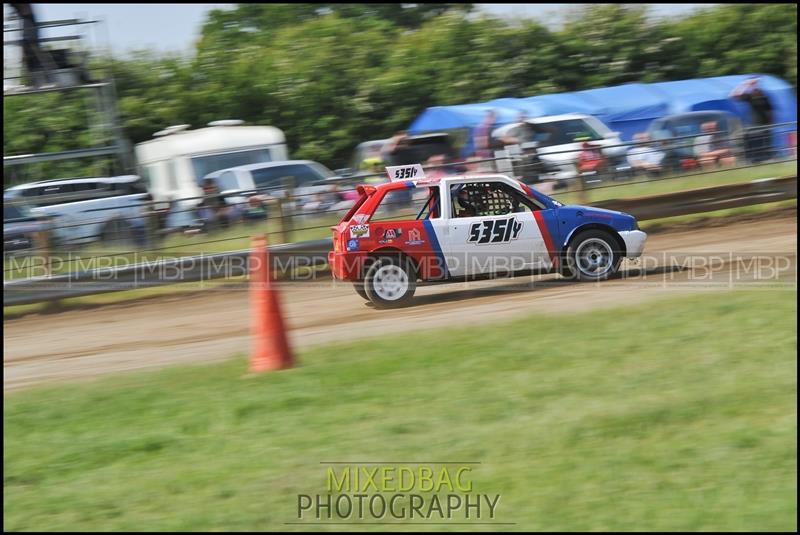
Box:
408;74;797;154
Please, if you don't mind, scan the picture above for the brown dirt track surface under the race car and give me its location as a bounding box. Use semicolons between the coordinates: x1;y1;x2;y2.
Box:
3;216;797;390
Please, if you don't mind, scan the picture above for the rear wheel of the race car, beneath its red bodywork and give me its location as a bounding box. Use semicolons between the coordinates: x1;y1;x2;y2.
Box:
364;257;417;308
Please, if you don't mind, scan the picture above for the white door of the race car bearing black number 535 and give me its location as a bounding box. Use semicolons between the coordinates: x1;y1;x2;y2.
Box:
437;180;550;277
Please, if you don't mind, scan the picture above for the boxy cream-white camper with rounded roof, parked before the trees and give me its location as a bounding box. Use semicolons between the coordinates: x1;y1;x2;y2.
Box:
135;120;289;204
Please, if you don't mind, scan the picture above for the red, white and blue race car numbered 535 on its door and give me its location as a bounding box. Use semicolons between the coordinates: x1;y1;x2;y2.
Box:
328;164;647;308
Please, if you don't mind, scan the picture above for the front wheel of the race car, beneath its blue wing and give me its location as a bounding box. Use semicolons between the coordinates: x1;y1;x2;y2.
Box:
562;229;622;281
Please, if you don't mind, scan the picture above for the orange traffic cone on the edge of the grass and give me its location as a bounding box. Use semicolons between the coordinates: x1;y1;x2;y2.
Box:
250;236;294;373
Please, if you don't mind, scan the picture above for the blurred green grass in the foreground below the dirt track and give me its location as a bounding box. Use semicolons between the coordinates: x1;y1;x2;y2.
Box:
3;290;797;531
